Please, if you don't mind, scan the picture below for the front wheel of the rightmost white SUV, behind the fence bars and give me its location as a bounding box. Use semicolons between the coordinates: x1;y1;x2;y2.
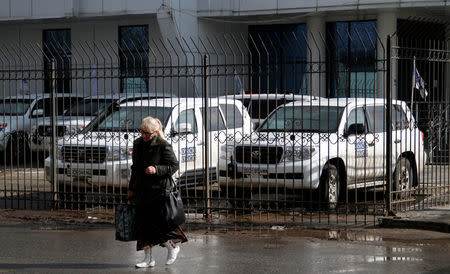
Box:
319;164;340;209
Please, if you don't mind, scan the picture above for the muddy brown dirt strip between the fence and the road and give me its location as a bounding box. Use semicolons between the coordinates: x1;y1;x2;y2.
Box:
0;209;450;244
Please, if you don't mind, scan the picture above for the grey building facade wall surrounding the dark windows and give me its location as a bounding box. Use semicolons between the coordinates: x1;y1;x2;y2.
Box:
0;0;444;97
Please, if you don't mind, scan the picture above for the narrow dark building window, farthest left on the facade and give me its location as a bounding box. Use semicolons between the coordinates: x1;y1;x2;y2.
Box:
42;29;72;93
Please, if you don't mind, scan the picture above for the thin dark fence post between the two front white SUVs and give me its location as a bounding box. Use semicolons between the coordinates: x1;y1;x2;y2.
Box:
203;55;211;219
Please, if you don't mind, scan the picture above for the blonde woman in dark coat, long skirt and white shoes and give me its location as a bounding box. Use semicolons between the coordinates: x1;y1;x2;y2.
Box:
128;117;187;268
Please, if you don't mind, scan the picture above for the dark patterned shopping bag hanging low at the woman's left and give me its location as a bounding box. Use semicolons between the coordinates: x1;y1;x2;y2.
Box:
115;204;136;242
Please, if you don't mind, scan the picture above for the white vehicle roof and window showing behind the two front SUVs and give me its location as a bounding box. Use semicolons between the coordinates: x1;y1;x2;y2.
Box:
224;93;318;129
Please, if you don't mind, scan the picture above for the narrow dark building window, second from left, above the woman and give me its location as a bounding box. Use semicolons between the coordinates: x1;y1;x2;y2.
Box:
119;26;149;93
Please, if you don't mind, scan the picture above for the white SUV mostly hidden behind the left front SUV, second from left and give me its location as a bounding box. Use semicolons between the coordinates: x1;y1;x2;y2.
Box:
30;93;167;152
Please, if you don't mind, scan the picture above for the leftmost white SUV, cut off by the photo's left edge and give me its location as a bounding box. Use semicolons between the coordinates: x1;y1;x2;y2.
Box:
0;93;83;162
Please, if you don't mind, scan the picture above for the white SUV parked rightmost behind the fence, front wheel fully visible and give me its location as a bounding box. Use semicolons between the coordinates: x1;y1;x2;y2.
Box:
218;98;426;207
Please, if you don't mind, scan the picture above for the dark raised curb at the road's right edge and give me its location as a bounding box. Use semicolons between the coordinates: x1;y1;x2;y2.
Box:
379;217;450;233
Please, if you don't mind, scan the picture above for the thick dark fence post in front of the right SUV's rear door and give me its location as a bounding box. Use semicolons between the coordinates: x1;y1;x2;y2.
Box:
385;35;392;214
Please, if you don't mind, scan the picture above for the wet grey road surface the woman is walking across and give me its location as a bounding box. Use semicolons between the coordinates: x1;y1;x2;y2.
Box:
0;223;450;273
